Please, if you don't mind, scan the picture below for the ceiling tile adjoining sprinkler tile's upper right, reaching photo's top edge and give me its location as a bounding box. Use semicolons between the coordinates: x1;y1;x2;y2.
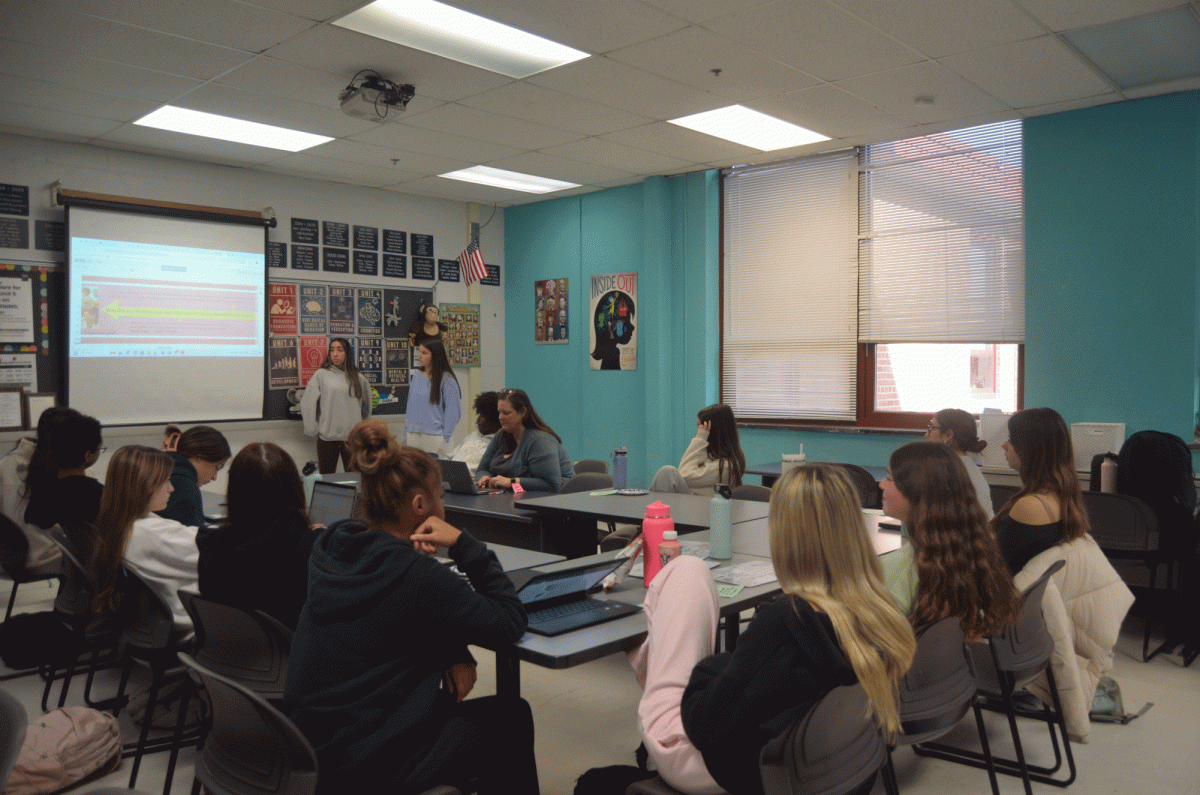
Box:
704;2;923;80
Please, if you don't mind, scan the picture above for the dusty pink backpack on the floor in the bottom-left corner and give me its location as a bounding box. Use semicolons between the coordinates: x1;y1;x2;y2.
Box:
4;706;121;795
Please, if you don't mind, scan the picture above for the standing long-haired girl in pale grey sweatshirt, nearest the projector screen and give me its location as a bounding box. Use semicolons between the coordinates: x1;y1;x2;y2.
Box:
300;336;371;474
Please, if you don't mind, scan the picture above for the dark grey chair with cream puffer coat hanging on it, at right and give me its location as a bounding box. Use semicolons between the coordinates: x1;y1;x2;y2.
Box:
913;561;1075;795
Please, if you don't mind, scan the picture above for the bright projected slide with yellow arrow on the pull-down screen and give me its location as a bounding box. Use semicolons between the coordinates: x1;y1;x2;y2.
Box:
70;238;264;358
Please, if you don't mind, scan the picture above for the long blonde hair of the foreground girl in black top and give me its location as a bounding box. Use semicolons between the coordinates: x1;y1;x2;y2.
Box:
768;464;917;741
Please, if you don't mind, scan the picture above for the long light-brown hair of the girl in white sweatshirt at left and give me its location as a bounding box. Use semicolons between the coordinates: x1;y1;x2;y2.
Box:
92;444;175;614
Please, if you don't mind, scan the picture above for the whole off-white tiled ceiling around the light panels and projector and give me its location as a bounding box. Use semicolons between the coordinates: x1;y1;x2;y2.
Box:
0;0;1200;205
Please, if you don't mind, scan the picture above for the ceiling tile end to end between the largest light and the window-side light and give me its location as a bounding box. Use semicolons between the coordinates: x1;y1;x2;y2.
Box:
526;58;727;120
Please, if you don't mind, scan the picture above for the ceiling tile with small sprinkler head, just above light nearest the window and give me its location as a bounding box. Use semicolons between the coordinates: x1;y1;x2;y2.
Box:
608;26;818;102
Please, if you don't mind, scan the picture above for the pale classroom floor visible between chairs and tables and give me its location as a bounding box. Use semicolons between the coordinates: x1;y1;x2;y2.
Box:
0;582;1200;795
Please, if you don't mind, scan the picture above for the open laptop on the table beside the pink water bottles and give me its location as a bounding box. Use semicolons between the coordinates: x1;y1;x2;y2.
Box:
510;557;642;635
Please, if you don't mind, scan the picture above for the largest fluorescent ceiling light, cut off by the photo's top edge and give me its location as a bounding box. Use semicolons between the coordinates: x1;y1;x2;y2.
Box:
334;0;588;79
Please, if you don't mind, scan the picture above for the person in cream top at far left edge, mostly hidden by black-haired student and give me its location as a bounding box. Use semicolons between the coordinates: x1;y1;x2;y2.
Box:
0;406;71;574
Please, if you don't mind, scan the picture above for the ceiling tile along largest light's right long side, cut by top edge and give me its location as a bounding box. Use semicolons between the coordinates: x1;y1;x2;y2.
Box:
450;0;686;55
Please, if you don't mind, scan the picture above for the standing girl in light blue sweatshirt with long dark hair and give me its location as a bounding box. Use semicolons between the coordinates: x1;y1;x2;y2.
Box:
402;340;462;456
